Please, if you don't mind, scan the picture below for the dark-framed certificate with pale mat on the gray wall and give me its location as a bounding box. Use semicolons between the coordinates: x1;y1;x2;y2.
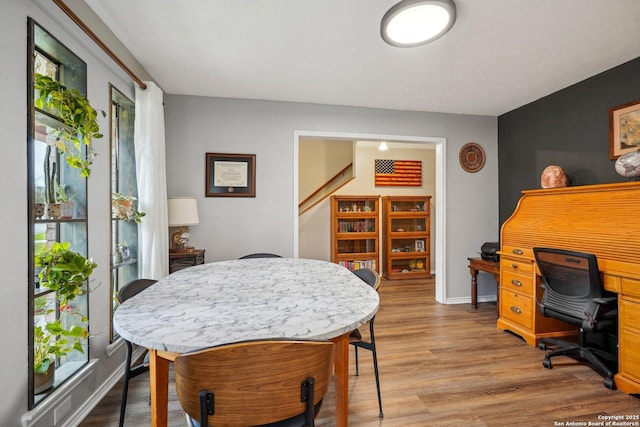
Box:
205;153;256;197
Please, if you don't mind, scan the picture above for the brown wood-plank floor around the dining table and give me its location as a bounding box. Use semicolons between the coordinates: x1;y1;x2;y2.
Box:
81;280;640;427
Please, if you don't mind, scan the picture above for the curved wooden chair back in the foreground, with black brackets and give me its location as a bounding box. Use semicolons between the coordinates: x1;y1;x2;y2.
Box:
175;340;333;427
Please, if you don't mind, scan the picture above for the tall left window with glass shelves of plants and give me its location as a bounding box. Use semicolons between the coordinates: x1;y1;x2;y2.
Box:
27;19;91;409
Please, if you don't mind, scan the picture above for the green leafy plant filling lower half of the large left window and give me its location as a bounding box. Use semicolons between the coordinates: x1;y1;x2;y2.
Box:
33;242;97;393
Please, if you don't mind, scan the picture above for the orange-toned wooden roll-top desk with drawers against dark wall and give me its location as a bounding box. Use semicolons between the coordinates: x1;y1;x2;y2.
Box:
497;182;640;394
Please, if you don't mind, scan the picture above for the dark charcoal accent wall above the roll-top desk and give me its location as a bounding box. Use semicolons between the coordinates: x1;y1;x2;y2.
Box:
498;58;640;224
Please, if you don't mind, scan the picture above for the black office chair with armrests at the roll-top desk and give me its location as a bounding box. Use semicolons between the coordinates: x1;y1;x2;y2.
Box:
533;248;618;390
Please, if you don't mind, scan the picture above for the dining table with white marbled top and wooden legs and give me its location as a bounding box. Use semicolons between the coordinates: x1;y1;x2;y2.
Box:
113;258;379;426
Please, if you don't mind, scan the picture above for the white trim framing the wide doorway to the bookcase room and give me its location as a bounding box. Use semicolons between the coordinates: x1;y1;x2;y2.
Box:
293;131;446;303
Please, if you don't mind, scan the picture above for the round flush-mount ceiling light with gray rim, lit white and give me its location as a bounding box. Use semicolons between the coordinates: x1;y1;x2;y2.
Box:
380;0;456;47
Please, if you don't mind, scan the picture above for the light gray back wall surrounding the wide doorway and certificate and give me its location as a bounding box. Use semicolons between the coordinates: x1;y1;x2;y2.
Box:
165;95;498;303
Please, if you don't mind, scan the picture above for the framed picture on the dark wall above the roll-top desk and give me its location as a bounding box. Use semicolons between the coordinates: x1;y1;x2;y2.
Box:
609;100;640;160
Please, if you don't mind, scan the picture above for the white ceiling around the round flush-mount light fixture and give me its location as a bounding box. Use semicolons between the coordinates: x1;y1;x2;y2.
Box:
86;0;640;116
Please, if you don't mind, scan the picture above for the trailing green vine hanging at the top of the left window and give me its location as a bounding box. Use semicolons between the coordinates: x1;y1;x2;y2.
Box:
34;74;102;177
